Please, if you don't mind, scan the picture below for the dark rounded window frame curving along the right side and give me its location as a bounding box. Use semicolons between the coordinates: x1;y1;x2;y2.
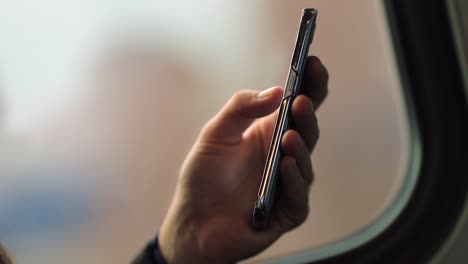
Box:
271;0;468;264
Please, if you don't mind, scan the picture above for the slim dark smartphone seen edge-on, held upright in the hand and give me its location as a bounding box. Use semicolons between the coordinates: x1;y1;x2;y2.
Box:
252;8;317;229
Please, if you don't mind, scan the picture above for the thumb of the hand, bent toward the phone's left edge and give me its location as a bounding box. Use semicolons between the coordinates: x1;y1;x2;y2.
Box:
202;87;283;142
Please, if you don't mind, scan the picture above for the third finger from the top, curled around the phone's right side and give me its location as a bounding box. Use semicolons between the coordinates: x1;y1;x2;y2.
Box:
281;130;314;185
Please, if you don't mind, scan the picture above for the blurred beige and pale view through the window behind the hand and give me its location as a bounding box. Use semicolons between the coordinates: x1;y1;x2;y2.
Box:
0;0;407;263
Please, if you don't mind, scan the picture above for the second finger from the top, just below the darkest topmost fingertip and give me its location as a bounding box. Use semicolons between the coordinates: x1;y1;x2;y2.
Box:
291;95;320;152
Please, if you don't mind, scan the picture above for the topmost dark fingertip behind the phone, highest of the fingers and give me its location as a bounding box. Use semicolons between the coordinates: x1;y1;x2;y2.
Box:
300;56;328;109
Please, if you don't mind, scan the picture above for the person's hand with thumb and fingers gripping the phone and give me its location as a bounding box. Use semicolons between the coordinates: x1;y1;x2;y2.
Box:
159;57;328;263
